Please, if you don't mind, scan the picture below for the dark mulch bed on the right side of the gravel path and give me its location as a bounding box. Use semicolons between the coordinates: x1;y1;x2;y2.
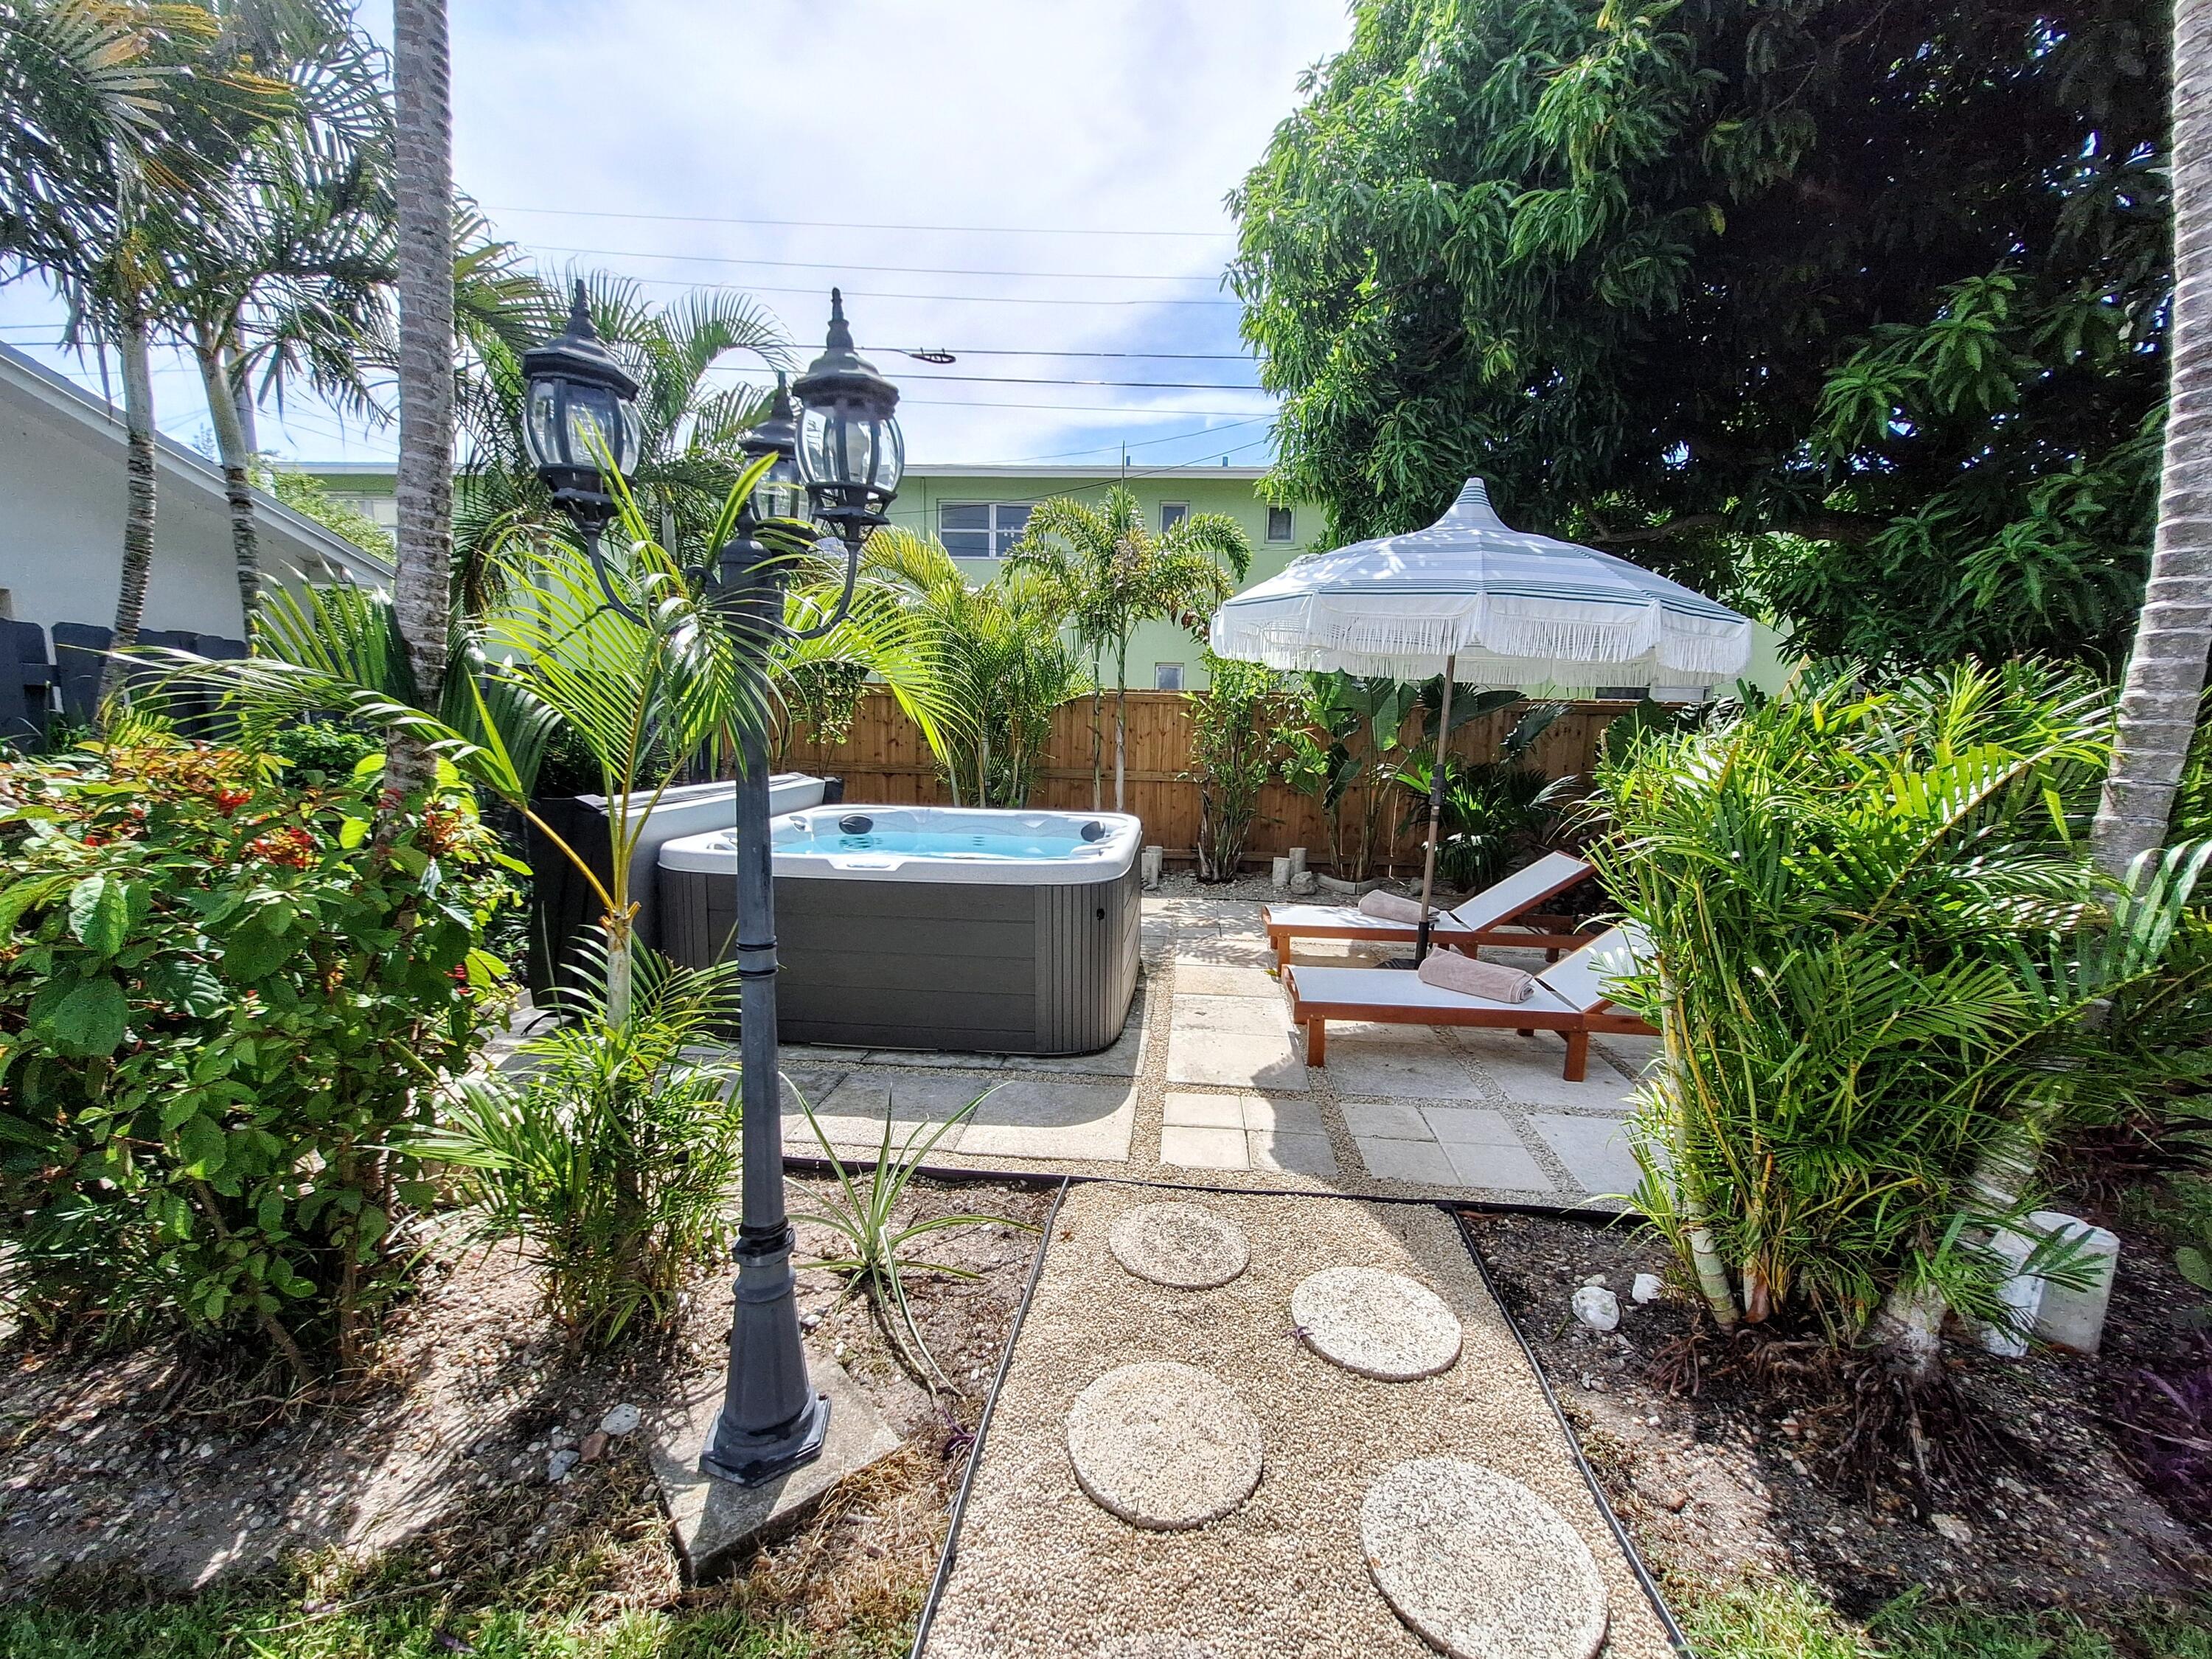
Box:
1471;1214;2212;1617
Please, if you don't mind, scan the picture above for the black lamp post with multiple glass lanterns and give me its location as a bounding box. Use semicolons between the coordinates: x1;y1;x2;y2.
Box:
524;285;905;1486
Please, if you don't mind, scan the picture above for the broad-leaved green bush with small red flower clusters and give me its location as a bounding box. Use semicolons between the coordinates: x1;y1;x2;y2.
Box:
0;741;515;1378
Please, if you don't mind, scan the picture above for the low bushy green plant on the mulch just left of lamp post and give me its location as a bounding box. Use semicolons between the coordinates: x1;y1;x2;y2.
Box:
438;936;743;1343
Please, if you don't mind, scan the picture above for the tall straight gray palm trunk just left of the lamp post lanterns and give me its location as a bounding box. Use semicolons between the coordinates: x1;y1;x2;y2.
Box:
380;0;453;834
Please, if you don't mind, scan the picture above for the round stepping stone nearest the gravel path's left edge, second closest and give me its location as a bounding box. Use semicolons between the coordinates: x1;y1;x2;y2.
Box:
1068;1360;1259;1531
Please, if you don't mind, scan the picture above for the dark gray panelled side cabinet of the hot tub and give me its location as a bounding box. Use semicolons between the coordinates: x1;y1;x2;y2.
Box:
659;860;1139;1055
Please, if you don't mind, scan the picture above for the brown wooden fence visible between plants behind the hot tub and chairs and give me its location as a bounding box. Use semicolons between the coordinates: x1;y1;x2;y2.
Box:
783;690;1635;874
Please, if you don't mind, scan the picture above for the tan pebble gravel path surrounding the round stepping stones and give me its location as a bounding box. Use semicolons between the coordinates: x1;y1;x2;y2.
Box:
927;1183;1670;1659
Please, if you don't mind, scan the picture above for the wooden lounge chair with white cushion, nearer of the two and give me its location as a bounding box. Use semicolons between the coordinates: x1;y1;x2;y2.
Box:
1283;927;1659;1084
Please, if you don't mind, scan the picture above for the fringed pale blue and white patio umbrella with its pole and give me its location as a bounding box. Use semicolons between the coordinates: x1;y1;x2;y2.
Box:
1210;478;1752;962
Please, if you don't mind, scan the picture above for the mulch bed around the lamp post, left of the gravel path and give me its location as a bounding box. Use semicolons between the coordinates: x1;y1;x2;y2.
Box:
0;1175;1051;1632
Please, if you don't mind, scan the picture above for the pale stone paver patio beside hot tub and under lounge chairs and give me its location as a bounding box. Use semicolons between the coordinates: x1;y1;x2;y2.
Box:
783;898;1655;1208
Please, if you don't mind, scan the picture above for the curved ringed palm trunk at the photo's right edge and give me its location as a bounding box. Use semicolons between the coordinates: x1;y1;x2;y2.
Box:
2090;0;2212;876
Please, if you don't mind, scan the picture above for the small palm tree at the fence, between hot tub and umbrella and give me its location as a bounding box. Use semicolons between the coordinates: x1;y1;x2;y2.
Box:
1009;484;1252;812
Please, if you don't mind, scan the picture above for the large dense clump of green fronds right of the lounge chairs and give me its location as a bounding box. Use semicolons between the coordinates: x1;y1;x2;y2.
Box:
1593;664;2205;1340
